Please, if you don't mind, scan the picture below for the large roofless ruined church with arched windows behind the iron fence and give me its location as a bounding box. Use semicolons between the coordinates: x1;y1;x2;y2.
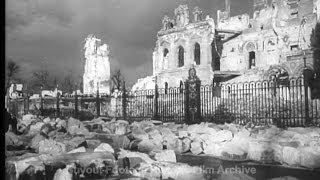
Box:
148;0;320;88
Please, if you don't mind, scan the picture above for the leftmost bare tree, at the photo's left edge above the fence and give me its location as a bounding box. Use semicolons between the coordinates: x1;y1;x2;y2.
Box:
5;60;21;94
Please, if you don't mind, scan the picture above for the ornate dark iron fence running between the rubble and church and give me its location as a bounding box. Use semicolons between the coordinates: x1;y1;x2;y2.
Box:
10;74;320;126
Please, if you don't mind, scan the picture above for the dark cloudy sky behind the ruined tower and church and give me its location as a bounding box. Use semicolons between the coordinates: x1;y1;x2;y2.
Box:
6;0;253;87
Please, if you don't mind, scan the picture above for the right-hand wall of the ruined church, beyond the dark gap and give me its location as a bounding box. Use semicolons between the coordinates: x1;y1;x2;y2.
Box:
217;0;317;76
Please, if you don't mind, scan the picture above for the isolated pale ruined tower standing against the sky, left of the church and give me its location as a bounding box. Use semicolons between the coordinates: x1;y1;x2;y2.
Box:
83;35;110;94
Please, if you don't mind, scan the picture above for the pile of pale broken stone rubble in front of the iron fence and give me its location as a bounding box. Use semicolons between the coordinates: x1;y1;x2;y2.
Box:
6;115;320;180
